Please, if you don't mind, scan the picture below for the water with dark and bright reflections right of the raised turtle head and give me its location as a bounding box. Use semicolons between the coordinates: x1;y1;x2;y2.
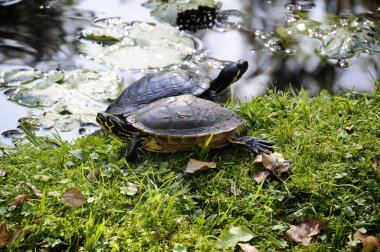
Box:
199;1;380;99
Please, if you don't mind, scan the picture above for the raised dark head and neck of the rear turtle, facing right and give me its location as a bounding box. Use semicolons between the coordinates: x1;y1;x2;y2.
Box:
210;60;248;93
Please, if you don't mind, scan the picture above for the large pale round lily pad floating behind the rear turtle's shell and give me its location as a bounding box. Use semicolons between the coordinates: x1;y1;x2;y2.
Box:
79;18;199;70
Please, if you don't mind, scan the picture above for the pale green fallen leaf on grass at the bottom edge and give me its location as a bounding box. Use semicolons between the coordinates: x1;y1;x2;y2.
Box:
217;226;253;249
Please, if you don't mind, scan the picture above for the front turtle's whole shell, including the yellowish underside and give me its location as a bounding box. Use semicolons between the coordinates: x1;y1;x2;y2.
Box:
125;95;245;153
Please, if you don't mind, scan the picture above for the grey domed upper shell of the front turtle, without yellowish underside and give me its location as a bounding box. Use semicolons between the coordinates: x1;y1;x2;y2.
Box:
126;95;245;137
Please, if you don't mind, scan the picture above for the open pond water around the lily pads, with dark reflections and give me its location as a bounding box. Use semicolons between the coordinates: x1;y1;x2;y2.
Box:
0;0;380;142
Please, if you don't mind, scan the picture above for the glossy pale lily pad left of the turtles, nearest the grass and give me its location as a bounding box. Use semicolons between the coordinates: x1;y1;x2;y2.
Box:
4;70;121;131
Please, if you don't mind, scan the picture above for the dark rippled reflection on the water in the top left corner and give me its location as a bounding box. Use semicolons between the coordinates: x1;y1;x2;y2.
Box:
0;0;92;68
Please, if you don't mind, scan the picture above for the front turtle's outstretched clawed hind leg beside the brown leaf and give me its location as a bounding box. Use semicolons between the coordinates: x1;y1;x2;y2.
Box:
231;136;274;155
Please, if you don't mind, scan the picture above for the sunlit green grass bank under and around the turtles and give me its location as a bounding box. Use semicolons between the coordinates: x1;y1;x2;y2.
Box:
0;87;380;251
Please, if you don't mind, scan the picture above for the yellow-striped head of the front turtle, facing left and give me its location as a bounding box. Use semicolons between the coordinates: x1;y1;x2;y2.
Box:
96;112;136;141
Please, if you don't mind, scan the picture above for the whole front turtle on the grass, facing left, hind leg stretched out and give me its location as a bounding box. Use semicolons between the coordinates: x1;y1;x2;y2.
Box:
96;95;273;160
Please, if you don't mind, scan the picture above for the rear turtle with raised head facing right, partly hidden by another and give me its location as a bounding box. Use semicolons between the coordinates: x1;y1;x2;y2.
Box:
106;60;248;115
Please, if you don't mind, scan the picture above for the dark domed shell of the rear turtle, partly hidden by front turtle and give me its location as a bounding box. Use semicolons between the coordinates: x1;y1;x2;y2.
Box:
106;71;210;115
